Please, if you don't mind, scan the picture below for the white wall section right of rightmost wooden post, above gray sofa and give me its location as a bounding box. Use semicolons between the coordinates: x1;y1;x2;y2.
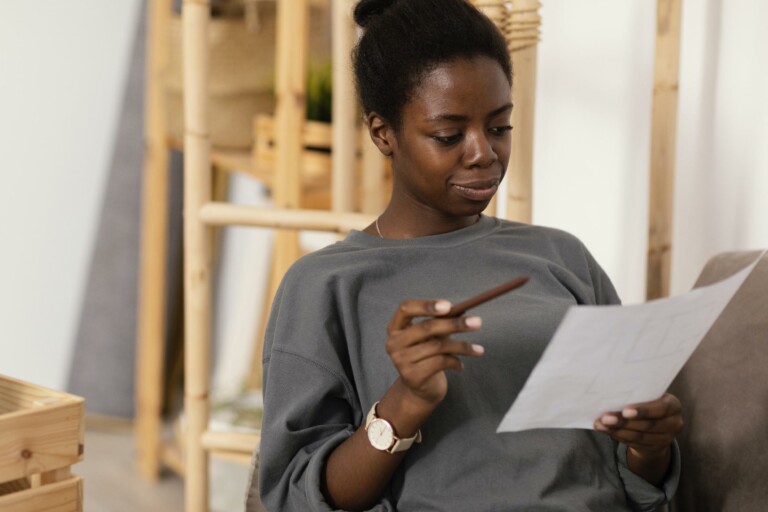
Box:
672;0;768;296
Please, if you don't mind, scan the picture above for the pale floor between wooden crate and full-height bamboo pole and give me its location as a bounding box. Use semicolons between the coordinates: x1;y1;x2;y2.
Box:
72;429;184;512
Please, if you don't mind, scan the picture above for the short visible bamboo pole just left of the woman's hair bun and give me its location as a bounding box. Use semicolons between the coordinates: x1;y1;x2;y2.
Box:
331;0;357;212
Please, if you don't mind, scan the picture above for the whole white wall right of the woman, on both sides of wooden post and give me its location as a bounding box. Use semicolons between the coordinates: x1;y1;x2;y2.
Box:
534;0;768;302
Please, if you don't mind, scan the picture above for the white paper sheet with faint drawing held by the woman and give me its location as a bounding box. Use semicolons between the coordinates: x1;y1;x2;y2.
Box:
497;255;762;432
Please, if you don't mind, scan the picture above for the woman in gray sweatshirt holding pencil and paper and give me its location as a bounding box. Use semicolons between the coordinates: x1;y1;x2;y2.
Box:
259;0;682;511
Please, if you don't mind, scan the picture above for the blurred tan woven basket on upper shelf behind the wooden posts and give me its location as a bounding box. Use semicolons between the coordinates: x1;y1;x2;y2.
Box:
165;2;330;149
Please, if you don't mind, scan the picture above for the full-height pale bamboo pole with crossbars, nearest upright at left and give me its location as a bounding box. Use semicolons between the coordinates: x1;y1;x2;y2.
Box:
182;0;211;512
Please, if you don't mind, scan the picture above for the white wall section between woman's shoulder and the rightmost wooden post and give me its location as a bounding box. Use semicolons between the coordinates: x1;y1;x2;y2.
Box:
533;0;655;301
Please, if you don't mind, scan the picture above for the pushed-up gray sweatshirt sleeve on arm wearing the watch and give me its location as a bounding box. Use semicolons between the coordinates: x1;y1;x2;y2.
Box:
258;265;391;512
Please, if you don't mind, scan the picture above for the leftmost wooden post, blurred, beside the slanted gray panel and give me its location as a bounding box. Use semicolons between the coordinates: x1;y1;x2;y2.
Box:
134;0;171;481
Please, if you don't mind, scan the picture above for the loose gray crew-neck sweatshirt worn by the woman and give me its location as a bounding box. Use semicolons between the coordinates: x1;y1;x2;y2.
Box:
259;216;679;512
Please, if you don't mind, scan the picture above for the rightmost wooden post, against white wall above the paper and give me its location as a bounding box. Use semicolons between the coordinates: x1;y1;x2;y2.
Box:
646;0;681;300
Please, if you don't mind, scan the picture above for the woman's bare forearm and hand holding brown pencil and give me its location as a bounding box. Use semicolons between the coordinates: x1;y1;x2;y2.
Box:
324;300;483;510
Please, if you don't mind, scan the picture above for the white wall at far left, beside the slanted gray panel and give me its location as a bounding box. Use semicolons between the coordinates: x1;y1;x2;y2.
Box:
0;0;140;389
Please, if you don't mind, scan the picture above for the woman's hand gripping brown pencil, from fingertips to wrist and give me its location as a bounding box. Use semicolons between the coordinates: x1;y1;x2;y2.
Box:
386;300;484;407
